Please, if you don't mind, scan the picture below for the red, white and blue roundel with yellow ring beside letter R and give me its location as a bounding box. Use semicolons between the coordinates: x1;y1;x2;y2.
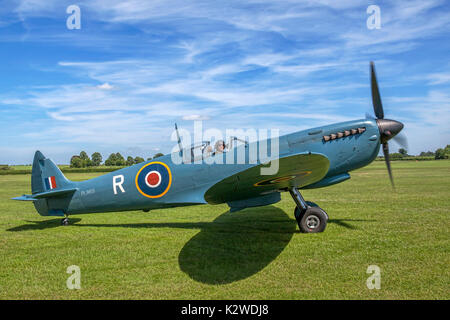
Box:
136;161;172;198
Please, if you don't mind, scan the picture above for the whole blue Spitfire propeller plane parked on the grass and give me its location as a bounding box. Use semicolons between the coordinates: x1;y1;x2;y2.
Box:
14;62;403;233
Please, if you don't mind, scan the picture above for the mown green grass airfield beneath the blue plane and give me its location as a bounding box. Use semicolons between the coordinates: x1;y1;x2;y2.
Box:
0;160;450;299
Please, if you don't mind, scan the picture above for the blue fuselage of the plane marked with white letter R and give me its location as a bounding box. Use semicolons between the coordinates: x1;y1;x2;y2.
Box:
66;119;380;214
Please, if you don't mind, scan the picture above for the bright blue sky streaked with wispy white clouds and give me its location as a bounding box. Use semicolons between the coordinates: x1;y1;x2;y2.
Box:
0;0;450;164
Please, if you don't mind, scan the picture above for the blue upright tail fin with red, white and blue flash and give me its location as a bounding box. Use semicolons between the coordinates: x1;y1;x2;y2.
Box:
31;151;71;194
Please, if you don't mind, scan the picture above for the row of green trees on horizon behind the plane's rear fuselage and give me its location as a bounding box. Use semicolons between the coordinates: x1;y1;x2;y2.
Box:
70;151;164;168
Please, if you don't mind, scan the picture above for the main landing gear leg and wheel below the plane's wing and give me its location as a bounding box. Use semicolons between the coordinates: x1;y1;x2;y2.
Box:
289;188;328;233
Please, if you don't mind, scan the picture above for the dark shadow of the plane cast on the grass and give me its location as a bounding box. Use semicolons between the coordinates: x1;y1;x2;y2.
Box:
8;206;372;284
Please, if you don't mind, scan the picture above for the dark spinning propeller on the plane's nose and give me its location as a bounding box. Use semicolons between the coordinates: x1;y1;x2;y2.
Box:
370;61;407;188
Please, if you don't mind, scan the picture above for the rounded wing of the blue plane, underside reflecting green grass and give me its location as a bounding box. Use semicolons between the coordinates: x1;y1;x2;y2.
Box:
205;152;330;204
